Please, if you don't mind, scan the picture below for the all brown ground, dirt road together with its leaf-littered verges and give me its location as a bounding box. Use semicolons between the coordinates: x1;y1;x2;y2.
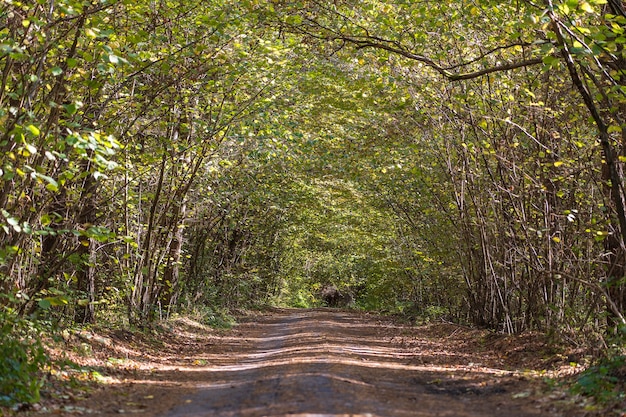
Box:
11;309;583;417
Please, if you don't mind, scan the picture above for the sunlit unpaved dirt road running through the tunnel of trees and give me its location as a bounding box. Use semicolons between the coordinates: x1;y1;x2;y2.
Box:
83;309;572;417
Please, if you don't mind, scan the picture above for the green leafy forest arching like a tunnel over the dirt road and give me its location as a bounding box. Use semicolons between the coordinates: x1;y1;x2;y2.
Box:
0;0;626;410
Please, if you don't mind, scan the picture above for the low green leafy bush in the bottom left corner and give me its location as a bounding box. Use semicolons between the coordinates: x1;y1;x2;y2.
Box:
0;307;49;406
